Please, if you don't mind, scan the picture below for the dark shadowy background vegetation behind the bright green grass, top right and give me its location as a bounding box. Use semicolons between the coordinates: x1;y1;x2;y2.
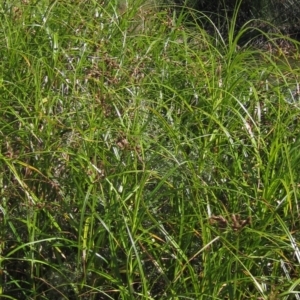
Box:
174;0;300;39
